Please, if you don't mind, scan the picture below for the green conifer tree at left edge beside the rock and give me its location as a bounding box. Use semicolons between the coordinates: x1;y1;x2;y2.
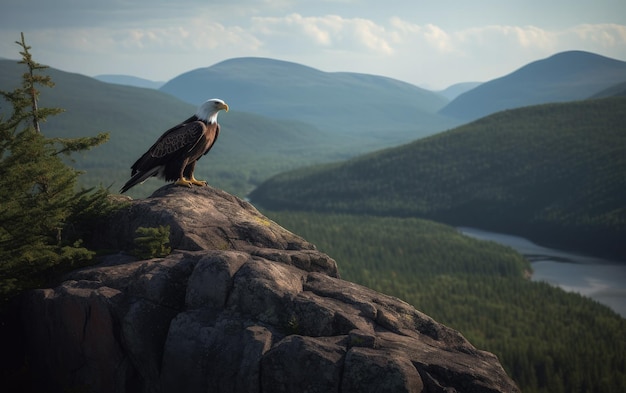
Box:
0;34;110;302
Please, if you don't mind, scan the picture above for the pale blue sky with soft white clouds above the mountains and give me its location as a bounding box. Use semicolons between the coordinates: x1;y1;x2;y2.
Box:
0;0;626;89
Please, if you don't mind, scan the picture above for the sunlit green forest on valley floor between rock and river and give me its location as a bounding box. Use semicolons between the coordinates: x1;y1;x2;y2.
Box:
264;211;626;393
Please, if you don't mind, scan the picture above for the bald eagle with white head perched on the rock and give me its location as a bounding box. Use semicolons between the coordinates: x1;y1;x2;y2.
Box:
120;98;228;193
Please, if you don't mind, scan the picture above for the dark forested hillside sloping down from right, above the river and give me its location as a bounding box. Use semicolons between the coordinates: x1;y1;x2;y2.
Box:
251;98;626;259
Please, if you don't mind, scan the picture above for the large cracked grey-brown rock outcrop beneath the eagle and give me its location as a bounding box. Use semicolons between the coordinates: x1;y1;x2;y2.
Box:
22;186;518;393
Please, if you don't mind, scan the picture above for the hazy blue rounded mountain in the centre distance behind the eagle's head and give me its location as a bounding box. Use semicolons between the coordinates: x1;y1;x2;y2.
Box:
161;58;457;146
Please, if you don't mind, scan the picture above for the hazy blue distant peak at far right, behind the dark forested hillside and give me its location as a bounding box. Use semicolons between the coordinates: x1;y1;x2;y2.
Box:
439;51;626;121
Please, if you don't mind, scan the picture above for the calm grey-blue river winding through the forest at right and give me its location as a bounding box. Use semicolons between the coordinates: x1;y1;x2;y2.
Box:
457;227;626;318
